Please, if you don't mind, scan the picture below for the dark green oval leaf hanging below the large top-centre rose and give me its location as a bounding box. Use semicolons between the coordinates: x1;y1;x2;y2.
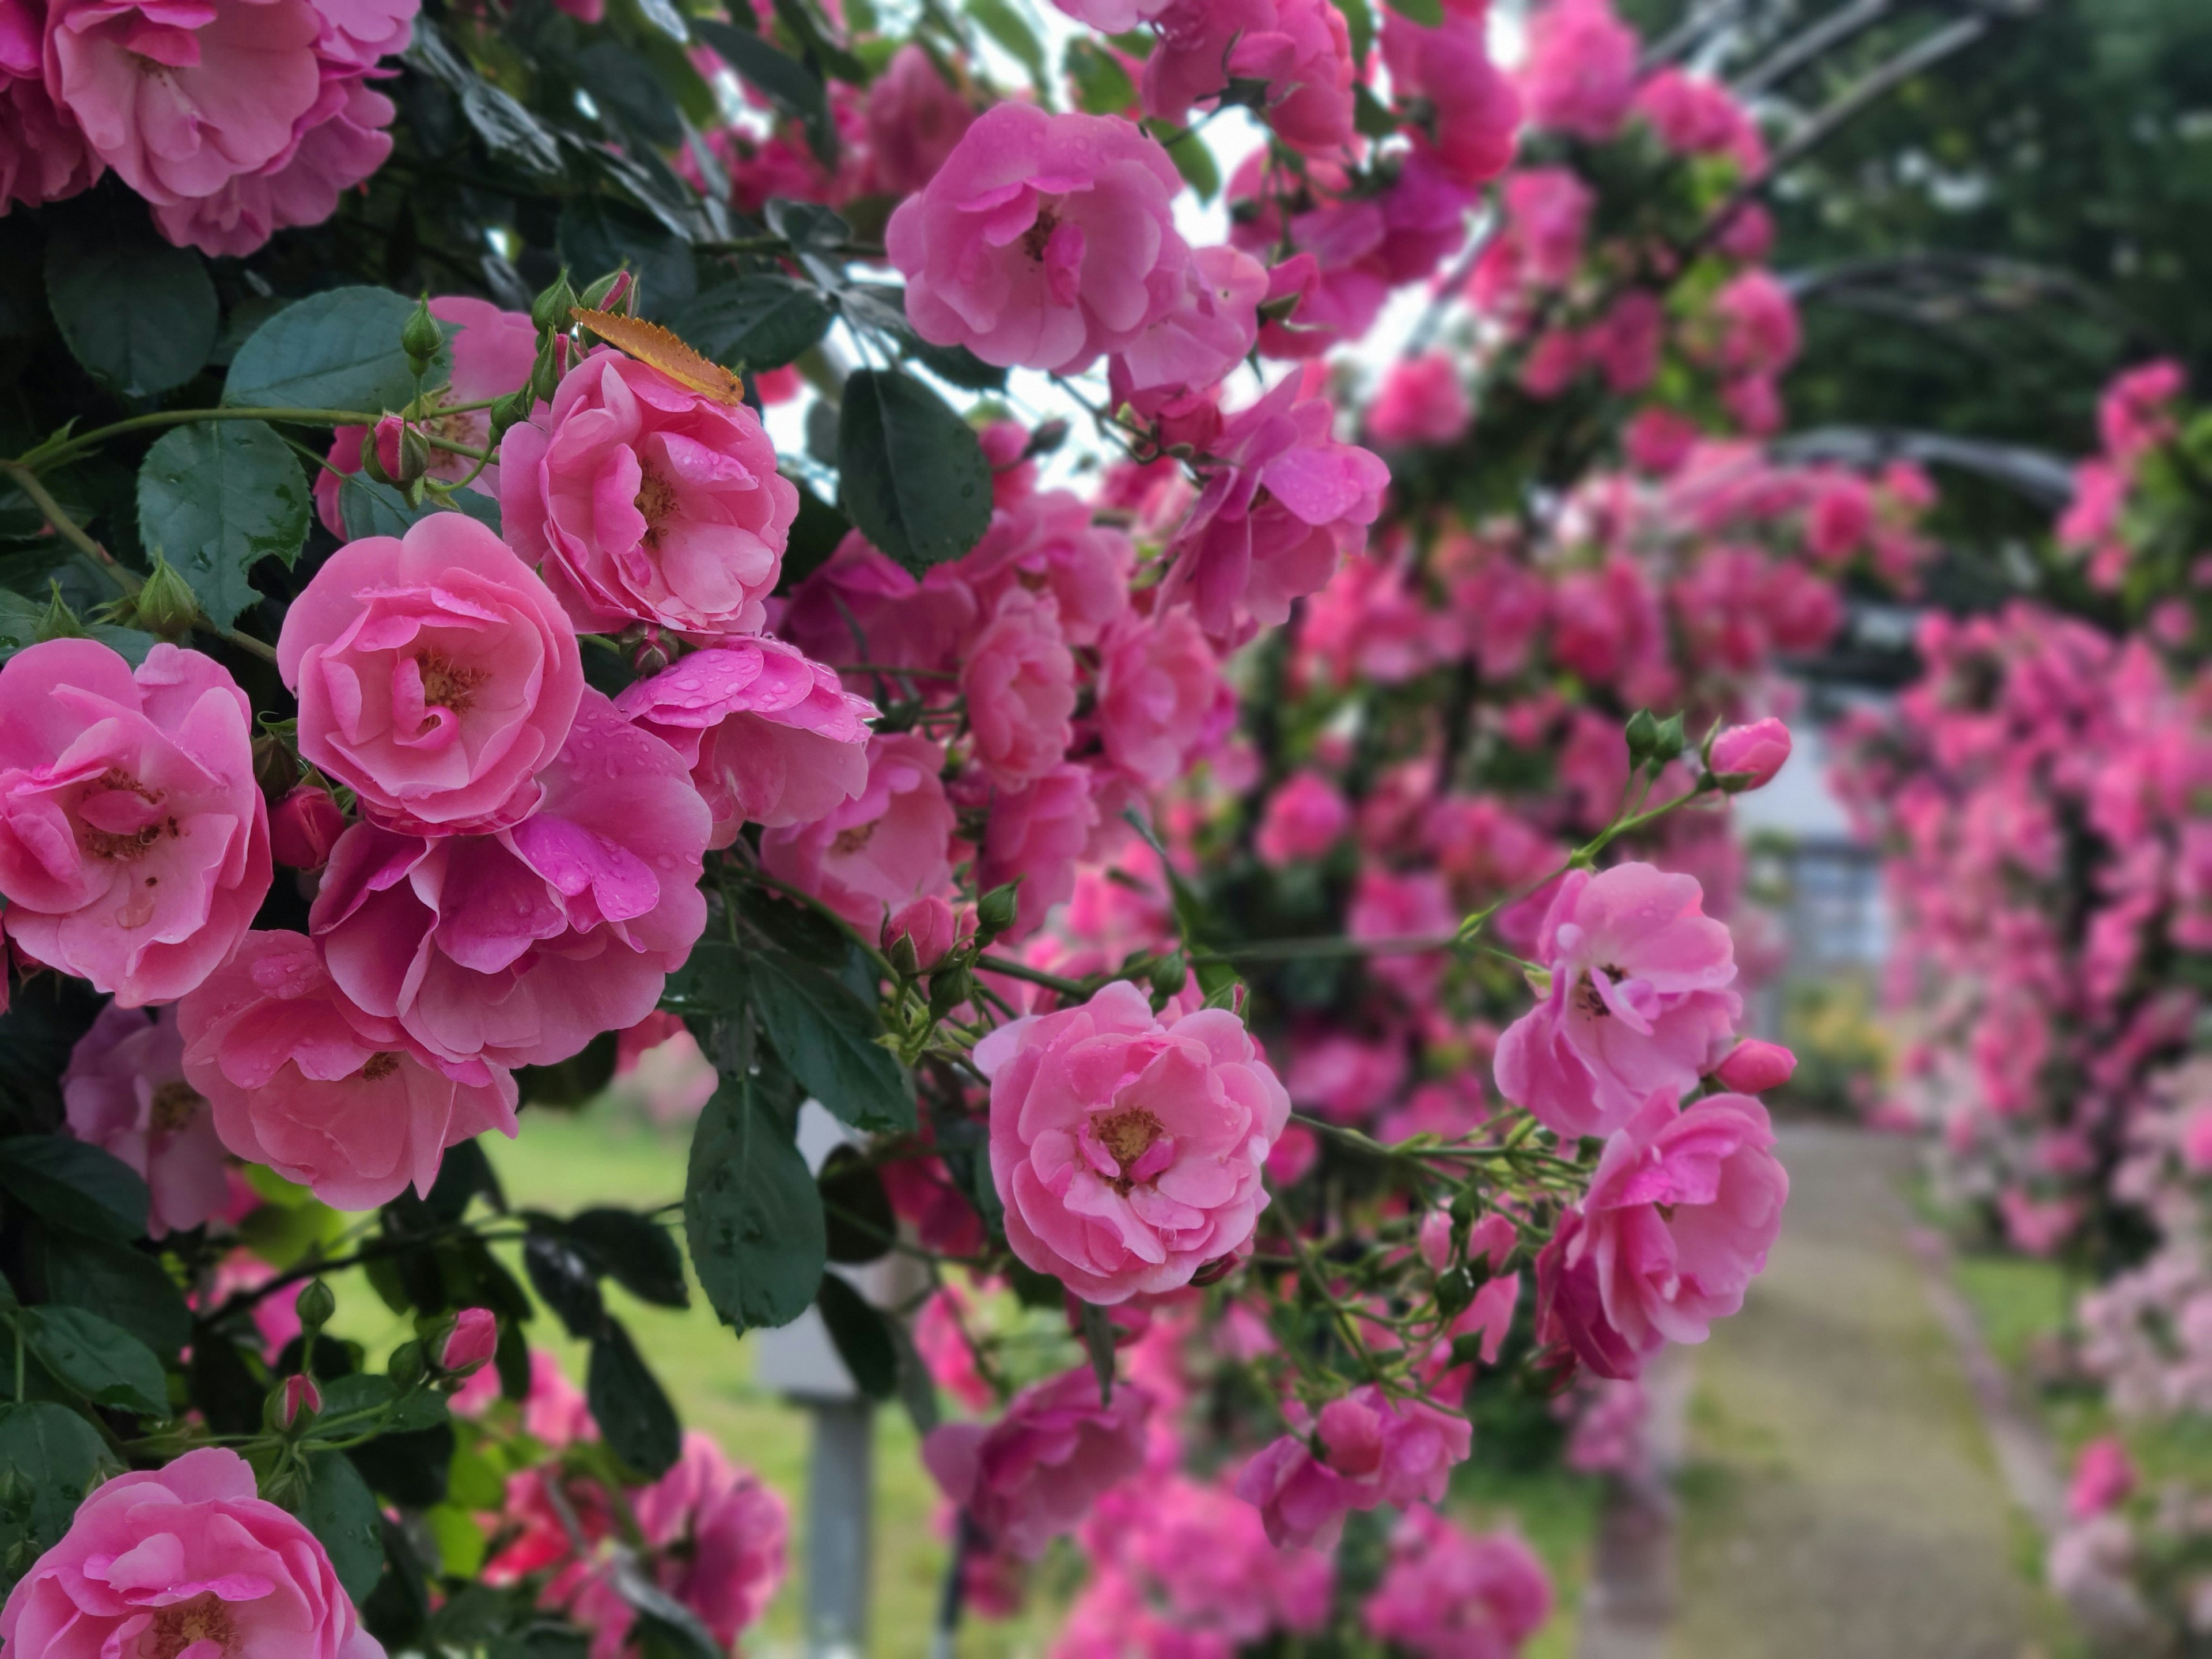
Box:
838;369;991;575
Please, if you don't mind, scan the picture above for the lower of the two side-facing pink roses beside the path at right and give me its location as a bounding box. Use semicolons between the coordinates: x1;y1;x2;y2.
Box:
1537;1088;1790;1380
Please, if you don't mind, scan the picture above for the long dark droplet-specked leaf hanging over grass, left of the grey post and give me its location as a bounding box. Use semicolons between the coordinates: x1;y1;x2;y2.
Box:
684;1075;827;1332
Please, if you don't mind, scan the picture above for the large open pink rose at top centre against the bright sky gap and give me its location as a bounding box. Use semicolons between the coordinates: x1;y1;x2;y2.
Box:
885;102;1190;374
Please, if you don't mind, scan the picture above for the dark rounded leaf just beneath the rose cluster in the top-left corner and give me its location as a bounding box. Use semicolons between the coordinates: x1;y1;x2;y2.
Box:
47;213;224;398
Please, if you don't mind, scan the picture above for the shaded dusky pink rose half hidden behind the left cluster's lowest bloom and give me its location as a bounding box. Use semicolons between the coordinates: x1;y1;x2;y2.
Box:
62;1002;230;1238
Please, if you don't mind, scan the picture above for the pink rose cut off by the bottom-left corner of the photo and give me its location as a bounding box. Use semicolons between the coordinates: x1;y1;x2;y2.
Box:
0;1446;385;1659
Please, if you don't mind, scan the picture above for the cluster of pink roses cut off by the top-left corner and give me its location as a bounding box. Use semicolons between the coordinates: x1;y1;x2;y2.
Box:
0;0;418;255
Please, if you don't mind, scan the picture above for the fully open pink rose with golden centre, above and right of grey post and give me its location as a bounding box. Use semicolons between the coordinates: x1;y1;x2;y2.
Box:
975;980;1290;1305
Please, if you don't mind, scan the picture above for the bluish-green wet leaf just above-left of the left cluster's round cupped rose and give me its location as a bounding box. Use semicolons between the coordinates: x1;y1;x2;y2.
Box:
139;421;308;628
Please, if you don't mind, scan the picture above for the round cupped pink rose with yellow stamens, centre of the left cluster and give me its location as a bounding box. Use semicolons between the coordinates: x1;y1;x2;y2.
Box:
276;513;584;836
